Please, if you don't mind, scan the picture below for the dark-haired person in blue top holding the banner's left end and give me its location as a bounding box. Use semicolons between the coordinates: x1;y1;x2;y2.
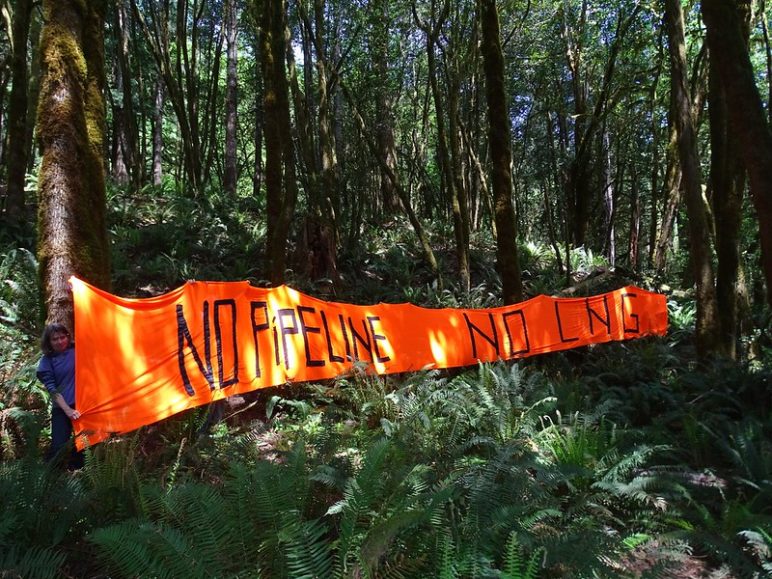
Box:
37;324;83;470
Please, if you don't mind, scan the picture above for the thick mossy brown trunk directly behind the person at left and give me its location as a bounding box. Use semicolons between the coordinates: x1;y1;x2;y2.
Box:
37;0;110;327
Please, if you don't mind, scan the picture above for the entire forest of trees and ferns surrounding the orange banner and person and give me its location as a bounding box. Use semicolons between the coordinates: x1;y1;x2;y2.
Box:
0;0;772;577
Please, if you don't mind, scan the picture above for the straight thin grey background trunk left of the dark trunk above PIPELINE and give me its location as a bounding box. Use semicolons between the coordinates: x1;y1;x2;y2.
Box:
223;0;238;196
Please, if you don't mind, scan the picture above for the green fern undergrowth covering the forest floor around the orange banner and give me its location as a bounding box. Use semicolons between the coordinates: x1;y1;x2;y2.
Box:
0;194;772;578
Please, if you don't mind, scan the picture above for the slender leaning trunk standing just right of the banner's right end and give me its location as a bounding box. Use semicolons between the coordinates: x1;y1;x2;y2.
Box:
665;0;720;356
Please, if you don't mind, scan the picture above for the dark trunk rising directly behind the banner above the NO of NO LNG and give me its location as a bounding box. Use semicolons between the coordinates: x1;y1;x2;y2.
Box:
478;0;523;304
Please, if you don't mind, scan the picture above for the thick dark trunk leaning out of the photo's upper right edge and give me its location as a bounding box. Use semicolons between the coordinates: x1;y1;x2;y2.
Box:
702;0;772;305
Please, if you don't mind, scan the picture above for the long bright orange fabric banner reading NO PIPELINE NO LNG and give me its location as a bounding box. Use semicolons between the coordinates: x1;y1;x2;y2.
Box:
70;277;667;446
